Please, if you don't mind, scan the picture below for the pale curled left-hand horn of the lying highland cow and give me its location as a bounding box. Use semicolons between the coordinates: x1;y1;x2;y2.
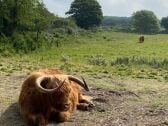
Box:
36;76;65;93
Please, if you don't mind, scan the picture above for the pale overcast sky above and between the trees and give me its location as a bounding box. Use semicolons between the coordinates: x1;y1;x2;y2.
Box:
43;0;168;19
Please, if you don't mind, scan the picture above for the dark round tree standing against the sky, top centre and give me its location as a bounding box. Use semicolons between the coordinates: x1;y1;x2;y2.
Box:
66;0;103;29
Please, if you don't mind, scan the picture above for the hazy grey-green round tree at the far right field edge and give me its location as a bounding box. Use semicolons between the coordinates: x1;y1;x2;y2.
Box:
132;10;159;34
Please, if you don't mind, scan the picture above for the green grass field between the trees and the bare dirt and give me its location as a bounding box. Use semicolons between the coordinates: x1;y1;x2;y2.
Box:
0;31;168;81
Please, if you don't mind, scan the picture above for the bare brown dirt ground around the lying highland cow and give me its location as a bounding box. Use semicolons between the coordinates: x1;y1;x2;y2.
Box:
0;74;168;126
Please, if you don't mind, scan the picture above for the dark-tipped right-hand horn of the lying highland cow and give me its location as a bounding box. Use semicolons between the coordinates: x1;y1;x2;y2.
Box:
68;75;89;91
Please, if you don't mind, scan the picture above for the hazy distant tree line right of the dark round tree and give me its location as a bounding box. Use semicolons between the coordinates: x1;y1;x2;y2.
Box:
102;10;168;34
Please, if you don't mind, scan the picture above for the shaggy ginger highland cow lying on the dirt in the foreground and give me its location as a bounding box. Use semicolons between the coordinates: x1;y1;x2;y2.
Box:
19;69;94;126
